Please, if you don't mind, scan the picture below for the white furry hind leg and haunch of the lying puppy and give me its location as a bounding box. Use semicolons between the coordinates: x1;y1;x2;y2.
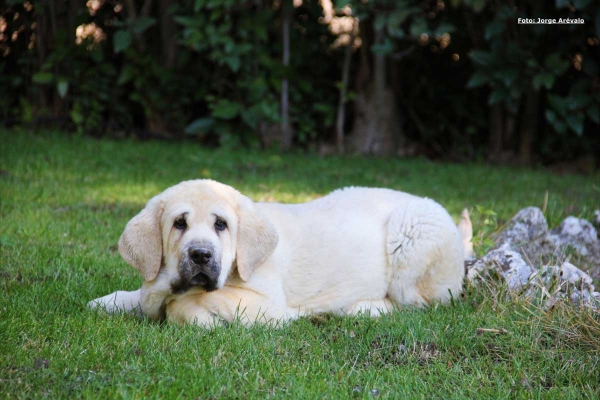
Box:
386;199;464;306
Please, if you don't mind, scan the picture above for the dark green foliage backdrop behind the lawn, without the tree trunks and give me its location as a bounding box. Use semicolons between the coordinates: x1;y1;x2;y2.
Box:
0;0;600;162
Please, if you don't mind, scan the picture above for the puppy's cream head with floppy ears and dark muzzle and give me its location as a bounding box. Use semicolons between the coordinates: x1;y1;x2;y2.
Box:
119;180;278;294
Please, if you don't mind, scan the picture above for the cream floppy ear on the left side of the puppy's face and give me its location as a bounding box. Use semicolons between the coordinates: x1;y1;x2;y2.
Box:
119;200;162;281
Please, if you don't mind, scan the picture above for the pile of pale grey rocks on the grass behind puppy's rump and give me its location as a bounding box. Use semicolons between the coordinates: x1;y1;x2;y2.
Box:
465;207;600;309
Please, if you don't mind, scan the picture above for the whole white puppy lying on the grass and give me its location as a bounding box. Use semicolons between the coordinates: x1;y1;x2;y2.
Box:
89;180;472;326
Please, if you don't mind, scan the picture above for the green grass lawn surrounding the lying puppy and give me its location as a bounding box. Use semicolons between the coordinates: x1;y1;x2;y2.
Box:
0;131;600;399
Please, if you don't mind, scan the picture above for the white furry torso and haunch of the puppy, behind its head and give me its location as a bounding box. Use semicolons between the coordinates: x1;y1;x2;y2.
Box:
257;188;464;312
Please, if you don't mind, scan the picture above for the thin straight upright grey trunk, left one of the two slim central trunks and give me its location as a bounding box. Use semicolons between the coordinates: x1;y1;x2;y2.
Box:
281;0;294;150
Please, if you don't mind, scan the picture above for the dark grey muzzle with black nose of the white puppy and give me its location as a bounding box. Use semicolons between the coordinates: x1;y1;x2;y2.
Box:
173;244;221;293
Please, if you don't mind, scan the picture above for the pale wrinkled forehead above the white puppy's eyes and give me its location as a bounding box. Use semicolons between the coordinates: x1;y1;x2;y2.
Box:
163;186;235;220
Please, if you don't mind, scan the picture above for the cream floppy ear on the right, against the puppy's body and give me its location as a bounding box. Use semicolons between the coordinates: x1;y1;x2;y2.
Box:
236;195;279;281
